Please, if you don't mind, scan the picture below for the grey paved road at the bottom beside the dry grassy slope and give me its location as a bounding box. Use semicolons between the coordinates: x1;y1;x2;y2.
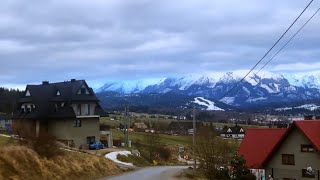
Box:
105;166;187;180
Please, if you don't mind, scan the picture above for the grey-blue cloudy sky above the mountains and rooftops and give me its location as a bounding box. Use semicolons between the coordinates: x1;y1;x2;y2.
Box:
0;0;320;87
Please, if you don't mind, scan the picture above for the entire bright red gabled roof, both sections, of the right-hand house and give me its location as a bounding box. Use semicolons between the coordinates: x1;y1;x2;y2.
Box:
238;120;320;169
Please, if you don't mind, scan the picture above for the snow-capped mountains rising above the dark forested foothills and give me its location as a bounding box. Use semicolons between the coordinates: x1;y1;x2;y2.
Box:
96;71;320;107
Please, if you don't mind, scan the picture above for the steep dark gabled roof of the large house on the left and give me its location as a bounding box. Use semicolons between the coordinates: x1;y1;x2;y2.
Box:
14;80;101;119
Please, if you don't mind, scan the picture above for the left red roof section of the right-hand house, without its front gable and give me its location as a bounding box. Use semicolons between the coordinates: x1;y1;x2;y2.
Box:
238;128;286;169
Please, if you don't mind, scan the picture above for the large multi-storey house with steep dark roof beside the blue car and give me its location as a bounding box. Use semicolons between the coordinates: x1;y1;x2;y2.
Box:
13;79;102;147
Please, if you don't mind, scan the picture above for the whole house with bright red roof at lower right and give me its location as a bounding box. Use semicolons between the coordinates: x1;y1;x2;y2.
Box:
238;120;320;180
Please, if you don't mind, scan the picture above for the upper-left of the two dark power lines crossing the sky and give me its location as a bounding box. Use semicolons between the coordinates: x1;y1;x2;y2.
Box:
219;0;314;101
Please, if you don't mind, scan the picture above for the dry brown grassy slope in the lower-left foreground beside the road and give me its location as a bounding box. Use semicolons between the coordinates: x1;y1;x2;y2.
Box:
0;137;122;180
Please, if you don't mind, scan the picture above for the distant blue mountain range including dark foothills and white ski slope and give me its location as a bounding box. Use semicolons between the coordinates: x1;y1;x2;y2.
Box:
96;71;320;110
